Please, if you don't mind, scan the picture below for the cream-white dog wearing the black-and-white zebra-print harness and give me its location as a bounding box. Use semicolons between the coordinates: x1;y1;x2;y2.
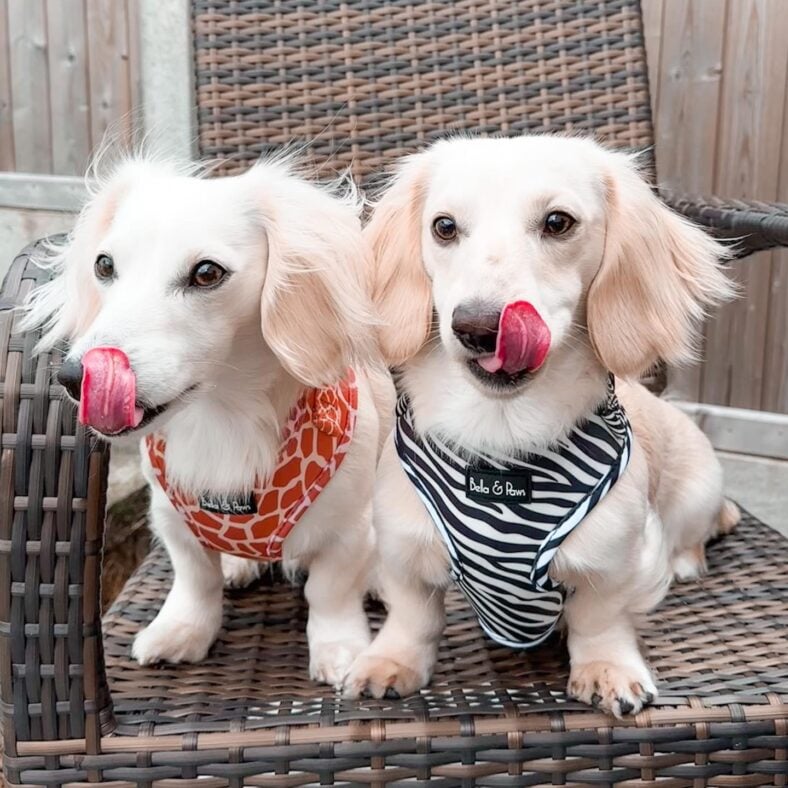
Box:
346;136;739;715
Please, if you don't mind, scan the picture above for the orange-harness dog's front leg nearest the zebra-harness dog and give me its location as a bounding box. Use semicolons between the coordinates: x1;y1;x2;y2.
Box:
304;506;372;689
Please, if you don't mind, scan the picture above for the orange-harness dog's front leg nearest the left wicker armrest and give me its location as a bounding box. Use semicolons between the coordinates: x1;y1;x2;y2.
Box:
131;487;223;665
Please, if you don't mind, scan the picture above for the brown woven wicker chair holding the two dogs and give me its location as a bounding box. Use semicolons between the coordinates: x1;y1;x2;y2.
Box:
0;0;788;788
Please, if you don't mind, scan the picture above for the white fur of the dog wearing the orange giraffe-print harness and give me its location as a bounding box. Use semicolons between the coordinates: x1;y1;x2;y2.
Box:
26;154;392;685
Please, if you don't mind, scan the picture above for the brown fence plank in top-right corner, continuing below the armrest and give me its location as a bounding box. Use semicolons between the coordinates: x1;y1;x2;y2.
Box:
702;0;788;408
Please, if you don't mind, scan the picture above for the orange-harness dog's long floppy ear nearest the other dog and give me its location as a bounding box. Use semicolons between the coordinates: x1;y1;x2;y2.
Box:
254;163;373;387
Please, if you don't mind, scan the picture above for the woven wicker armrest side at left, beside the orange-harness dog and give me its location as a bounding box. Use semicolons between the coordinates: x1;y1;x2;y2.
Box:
0;242;113;784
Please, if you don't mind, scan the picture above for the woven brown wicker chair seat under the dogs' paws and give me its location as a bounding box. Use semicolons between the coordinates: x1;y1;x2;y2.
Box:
102;514;788;786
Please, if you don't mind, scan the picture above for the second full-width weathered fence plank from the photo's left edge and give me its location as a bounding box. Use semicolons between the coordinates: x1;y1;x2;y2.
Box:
46;0;90;175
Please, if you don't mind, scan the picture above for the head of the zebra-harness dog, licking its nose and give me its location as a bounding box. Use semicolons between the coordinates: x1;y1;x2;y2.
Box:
365;136;732;392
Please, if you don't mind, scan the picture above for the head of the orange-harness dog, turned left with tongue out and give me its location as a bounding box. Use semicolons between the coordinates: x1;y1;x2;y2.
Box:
26;160;370;435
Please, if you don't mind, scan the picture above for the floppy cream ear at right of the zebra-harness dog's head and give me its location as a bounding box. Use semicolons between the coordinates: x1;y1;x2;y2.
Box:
587;152;735;376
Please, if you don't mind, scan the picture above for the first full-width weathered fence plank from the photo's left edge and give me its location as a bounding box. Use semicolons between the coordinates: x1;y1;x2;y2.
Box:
8;0;52;172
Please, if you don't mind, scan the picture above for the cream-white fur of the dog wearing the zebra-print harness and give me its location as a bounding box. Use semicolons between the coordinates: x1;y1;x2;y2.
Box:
346;136;731;715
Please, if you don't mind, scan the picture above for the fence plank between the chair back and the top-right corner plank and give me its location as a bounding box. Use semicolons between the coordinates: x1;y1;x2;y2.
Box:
655;0;727;400
